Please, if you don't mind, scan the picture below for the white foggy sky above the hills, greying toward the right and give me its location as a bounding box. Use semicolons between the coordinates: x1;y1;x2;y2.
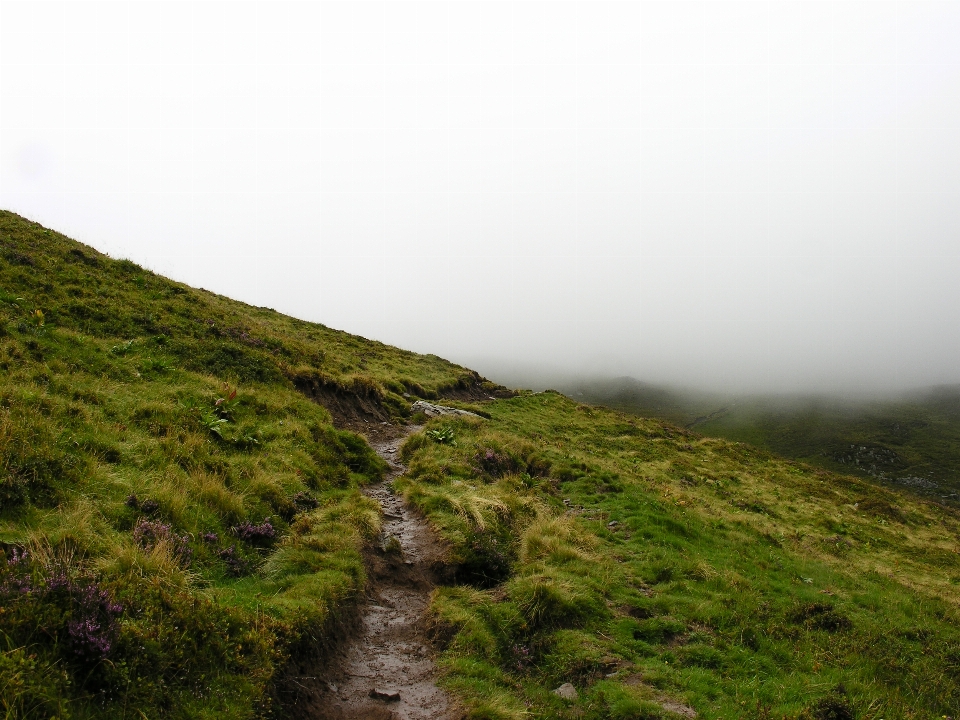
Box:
0;1;960;391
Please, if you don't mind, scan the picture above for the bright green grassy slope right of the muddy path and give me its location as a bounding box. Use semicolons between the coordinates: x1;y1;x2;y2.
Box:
398;391;960;720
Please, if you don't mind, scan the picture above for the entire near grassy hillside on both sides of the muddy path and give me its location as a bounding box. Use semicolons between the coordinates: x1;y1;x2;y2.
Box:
0;213;960;720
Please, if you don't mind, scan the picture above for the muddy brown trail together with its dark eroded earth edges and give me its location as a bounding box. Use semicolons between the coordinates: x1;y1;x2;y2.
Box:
277;410;464;720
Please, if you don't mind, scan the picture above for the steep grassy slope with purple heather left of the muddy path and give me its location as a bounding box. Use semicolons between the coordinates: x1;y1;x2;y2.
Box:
0;213;492;718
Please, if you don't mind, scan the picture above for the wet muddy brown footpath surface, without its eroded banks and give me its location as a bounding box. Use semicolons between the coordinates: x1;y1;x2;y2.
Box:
311;426;460;720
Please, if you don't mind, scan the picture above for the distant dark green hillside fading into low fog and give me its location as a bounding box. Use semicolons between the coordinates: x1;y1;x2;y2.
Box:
565;378;960;504
